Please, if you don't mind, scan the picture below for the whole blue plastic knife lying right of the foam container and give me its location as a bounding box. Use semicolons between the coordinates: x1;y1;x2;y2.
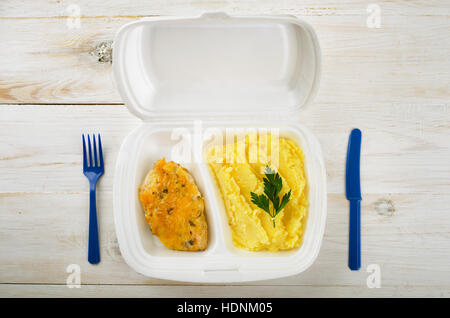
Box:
345;128;362;271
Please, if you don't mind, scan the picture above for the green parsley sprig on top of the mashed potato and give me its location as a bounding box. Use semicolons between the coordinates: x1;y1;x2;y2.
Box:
250;166;291;227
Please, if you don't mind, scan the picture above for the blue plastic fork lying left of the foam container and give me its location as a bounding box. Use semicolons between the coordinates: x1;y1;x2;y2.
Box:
82;134;105;264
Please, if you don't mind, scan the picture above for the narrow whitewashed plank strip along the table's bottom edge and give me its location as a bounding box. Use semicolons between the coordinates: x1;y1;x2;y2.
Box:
0;284;450;298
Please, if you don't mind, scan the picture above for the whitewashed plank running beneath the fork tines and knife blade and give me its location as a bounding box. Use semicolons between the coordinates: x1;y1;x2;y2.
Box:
0;103;450;194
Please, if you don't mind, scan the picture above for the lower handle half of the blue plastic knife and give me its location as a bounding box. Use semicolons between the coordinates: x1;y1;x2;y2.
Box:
348;200;361;271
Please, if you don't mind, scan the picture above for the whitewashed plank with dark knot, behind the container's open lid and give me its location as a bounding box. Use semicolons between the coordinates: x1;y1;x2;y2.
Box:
0;11;450;103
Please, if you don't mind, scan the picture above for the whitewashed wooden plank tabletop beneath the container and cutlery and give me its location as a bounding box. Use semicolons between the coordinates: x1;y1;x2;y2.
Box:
0;0;450;297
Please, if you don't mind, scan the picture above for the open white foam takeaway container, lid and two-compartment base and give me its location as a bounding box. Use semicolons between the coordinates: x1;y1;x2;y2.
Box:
113;13;326;282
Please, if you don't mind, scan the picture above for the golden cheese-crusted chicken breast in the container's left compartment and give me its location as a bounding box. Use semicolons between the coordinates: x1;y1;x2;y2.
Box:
139;158;208;251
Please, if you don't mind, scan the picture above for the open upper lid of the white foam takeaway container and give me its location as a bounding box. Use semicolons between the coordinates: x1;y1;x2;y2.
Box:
113;13;321;120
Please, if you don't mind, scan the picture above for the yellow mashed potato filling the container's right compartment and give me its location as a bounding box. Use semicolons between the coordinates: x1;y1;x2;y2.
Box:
206;134;308;251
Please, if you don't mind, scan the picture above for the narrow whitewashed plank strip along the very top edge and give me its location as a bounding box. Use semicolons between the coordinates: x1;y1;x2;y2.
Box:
0;0;449;17
